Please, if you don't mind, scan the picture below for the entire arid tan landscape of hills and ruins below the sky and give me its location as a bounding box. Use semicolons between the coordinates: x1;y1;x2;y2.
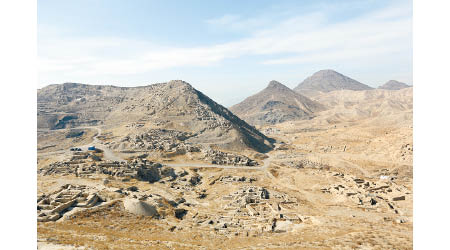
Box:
37;71;413;249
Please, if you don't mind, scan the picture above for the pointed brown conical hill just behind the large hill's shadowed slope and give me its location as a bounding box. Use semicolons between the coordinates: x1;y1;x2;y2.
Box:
230;81;325;125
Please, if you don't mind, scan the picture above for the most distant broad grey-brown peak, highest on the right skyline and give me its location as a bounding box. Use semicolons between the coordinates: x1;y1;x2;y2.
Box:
294;69;372;93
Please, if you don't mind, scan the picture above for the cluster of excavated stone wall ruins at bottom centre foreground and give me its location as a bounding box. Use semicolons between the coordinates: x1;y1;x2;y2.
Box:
192;186;305;235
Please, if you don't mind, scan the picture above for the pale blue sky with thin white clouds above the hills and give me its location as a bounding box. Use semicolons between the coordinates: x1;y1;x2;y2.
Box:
37;0;412;106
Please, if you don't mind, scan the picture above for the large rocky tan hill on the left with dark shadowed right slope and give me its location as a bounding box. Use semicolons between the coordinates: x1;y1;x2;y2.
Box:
37;80;272;152
